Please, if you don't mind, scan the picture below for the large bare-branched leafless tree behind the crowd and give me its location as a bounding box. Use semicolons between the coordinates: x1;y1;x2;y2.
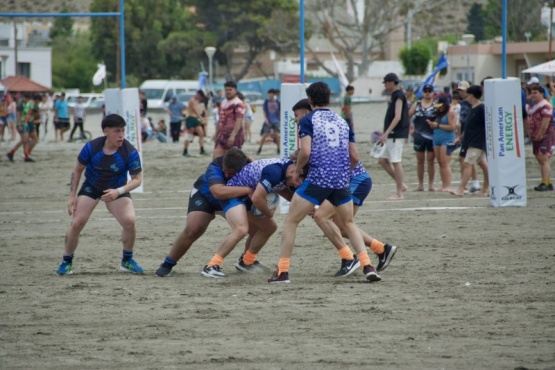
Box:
307;0;446;81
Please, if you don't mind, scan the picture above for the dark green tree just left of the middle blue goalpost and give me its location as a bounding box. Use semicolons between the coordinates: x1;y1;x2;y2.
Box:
191;0;299;81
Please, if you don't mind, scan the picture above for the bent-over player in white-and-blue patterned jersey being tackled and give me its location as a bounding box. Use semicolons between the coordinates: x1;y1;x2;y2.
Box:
201;158;295;278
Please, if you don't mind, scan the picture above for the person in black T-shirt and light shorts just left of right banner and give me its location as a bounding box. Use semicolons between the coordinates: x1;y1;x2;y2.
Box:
451;85;489;197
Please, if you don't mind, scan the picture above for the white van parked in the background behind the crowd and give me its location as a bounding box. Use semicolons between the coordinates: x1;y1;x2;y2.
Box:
139;80;198;109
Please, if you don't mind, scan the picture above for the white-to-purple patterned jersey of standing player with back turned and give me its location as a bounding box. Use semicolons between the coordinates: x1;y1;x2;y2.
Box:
299;109;355;189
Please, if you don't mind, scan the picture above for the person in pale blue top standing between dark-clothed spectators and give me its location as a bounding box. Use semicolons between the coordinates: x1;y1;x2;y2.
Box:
427;95;457;192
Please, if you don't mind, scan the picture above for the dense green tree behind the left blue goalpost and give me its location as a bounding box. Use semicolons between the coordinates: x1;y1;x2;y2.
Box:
91;0;199;84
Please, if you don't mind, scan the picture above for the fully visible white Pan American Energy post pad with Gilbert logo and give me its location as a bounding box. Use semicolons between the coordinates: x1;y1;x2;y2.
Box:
484;77;526;207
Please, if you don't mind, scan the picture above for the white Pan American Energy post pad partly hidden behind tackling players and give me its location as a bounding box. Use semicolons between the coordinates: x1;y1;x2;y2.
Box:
280;83;308;214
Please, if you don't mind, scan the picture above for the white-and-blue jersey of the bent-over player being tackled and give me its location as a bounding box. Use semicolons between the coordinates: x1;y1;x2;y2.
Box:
227;158;293;193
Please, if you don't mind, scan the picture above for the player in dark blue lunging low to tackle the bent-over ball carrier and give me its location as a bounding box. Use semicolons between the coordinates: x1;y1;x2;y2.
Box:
155;148;252;277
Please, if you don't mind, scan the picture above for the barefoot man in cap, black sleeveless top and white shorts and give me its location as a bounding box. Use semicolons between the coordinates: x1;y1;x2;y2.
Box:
378;73;409;200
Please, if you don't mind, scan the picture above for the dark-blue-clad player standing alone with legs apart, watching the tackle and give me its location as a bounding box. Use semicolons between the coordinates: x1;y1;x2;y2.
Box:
56;114;143;275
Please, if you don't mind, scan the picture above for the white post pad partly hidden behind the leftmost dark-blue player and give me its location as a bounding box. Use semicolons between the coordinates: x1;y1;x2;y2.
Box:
104;88;145;193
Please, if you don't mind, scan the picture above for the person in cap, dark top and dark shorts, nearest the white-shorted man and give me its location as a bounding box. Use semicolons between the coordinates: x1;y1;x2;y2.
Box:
409;84;436;191
